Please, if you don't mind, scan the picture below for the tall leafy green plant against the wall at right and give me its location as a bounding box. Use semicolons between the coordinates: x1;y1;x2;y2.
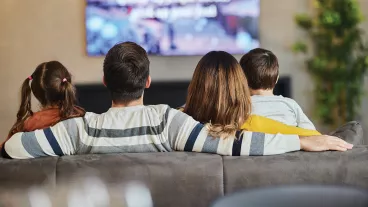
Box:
293;0;368;127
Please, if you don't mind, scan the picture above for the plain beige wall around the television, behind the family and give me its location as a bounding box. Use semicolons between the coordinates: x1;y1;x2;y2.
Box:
0;0;368;140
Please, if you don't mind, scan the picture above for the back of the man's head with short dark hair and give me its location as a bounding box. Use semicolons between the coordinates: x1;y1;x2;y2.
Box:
103;42;150;103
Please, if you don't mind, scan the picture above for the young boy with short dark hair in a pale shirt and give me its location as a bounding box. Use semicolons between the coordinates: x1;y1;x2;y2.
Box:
240;48;316;130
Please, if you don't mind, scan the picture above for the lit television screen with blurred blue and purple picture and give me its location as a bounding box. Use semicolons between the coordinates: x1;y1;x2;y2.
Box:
85;0;260;56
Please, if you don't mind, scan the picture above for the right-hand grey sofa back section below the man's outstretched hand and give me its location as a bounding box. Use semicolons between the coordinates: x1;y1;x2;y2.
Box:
223;146;368;194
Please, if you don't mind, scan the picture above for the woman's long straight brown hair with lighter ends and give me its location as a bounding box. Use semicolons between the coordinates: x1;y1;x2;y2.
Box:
184;51;251;138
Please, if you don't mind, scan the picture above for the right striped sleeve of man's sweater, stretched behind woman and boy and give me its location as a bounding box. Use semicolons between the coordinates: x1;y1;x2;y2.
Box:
169;109;300;156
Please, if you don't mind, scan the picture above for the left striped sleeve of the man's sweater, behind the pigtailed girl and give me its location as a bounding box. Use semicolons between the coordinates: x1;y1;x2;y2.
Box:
2;118;82;159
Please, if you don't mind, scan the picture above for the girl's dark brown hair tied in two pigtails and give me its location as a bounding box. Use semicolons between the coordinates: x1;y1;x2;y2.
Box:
10;61;84;134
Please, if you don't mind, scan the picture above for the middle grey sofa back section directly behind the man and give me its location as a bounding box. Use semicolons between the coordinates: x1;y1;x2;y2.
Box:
57;152;223;207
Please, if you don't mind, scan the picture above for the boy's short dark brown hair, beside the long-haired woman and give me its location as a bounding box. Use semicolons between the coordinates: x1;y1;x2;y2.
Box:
240;48;279;90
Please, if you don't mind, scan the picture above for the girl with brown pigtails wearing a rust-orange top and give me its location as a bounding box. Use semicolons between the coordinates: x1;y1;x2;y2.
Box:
0;61;85;147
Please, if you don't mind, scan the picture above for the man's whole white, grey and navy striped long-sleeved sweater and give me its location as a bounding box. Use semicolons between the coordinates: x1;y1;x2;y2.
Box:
2;105;300;159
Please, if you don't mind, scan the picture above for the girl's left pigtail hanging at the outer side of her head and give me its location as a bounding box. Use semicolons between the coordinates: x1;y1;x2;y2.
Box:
9;77;33;137
